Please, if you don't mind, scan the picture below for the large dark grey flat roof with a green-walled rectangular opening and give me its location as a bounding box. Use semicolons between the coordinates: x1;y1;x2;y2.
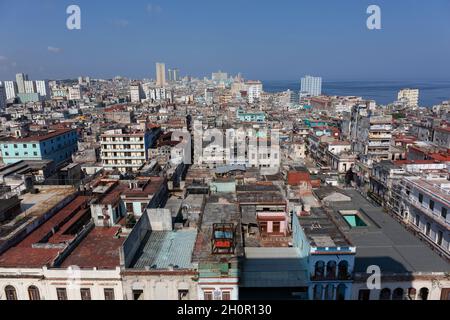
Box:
329;189;450;274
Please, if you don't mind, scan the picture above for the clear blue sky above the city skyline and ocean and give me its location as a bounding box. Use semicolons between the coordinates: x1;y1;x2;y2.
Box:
0;0;450;80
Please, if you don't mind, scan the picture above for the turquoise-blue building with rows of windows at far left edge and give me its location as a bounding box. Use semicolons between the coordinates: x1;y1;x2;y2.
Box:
0;129;78;166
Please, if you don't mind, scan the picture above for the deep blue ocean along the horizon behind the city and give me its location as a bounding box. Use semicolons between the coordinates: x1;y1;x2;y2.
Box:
263;80;450;107
